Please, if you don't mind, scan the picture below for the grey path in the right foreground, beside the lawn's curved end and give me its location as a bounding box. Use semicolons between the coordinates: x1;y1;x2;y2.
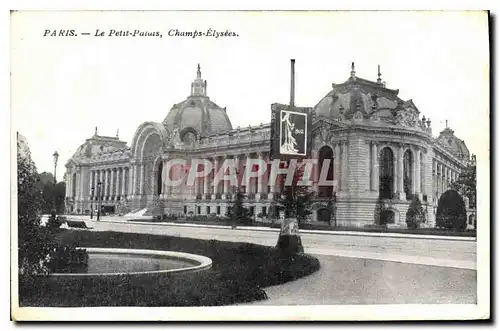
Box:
250;255;477;306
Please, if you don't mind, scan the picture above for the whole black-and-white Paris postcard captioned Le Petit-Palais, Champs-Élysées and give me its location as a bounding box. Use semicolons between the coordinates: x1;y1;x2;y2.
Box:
10;10;490;321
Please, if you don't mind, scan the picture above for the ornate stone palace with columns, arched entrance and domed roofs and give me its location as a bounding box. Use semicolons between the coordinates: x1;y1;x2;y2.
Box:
65;65;471;227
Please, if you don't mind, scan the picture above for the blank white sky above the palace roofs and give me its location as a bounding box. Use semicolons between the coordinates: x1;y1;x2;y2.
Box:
11;11;490;180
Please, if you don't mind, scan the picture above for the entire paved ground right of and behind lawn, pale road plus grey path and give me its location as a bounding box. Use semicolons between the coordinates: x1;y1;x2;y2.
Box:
67;219;477;305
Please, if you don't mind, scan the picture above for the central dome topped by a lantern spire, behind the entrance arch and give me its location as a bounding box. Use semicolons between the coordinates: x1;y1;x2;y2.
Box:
163;64;232;140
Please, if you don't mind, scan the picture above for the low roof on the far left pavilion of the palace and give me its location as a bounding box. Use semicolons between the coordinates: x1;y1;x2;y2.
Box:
72;128;127;160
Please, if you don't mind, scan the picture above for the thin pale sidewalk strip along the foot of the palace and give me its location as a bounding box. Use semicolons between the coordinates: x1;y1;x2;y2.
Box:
67;215;476;241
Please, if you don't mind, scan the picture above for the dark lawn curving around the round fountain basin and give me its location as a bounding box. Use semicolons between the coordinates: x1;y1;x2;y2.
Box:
19;230;320;307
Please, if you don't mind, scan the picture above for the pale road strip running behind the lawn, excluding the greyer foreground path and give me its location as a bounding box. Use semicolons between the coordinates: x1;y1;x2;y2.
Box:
81;219;476;270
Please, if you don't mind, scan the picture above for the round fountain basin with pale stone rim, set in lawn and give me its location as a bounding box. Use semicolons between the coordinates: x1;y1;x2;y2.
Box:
51;247;212;278
